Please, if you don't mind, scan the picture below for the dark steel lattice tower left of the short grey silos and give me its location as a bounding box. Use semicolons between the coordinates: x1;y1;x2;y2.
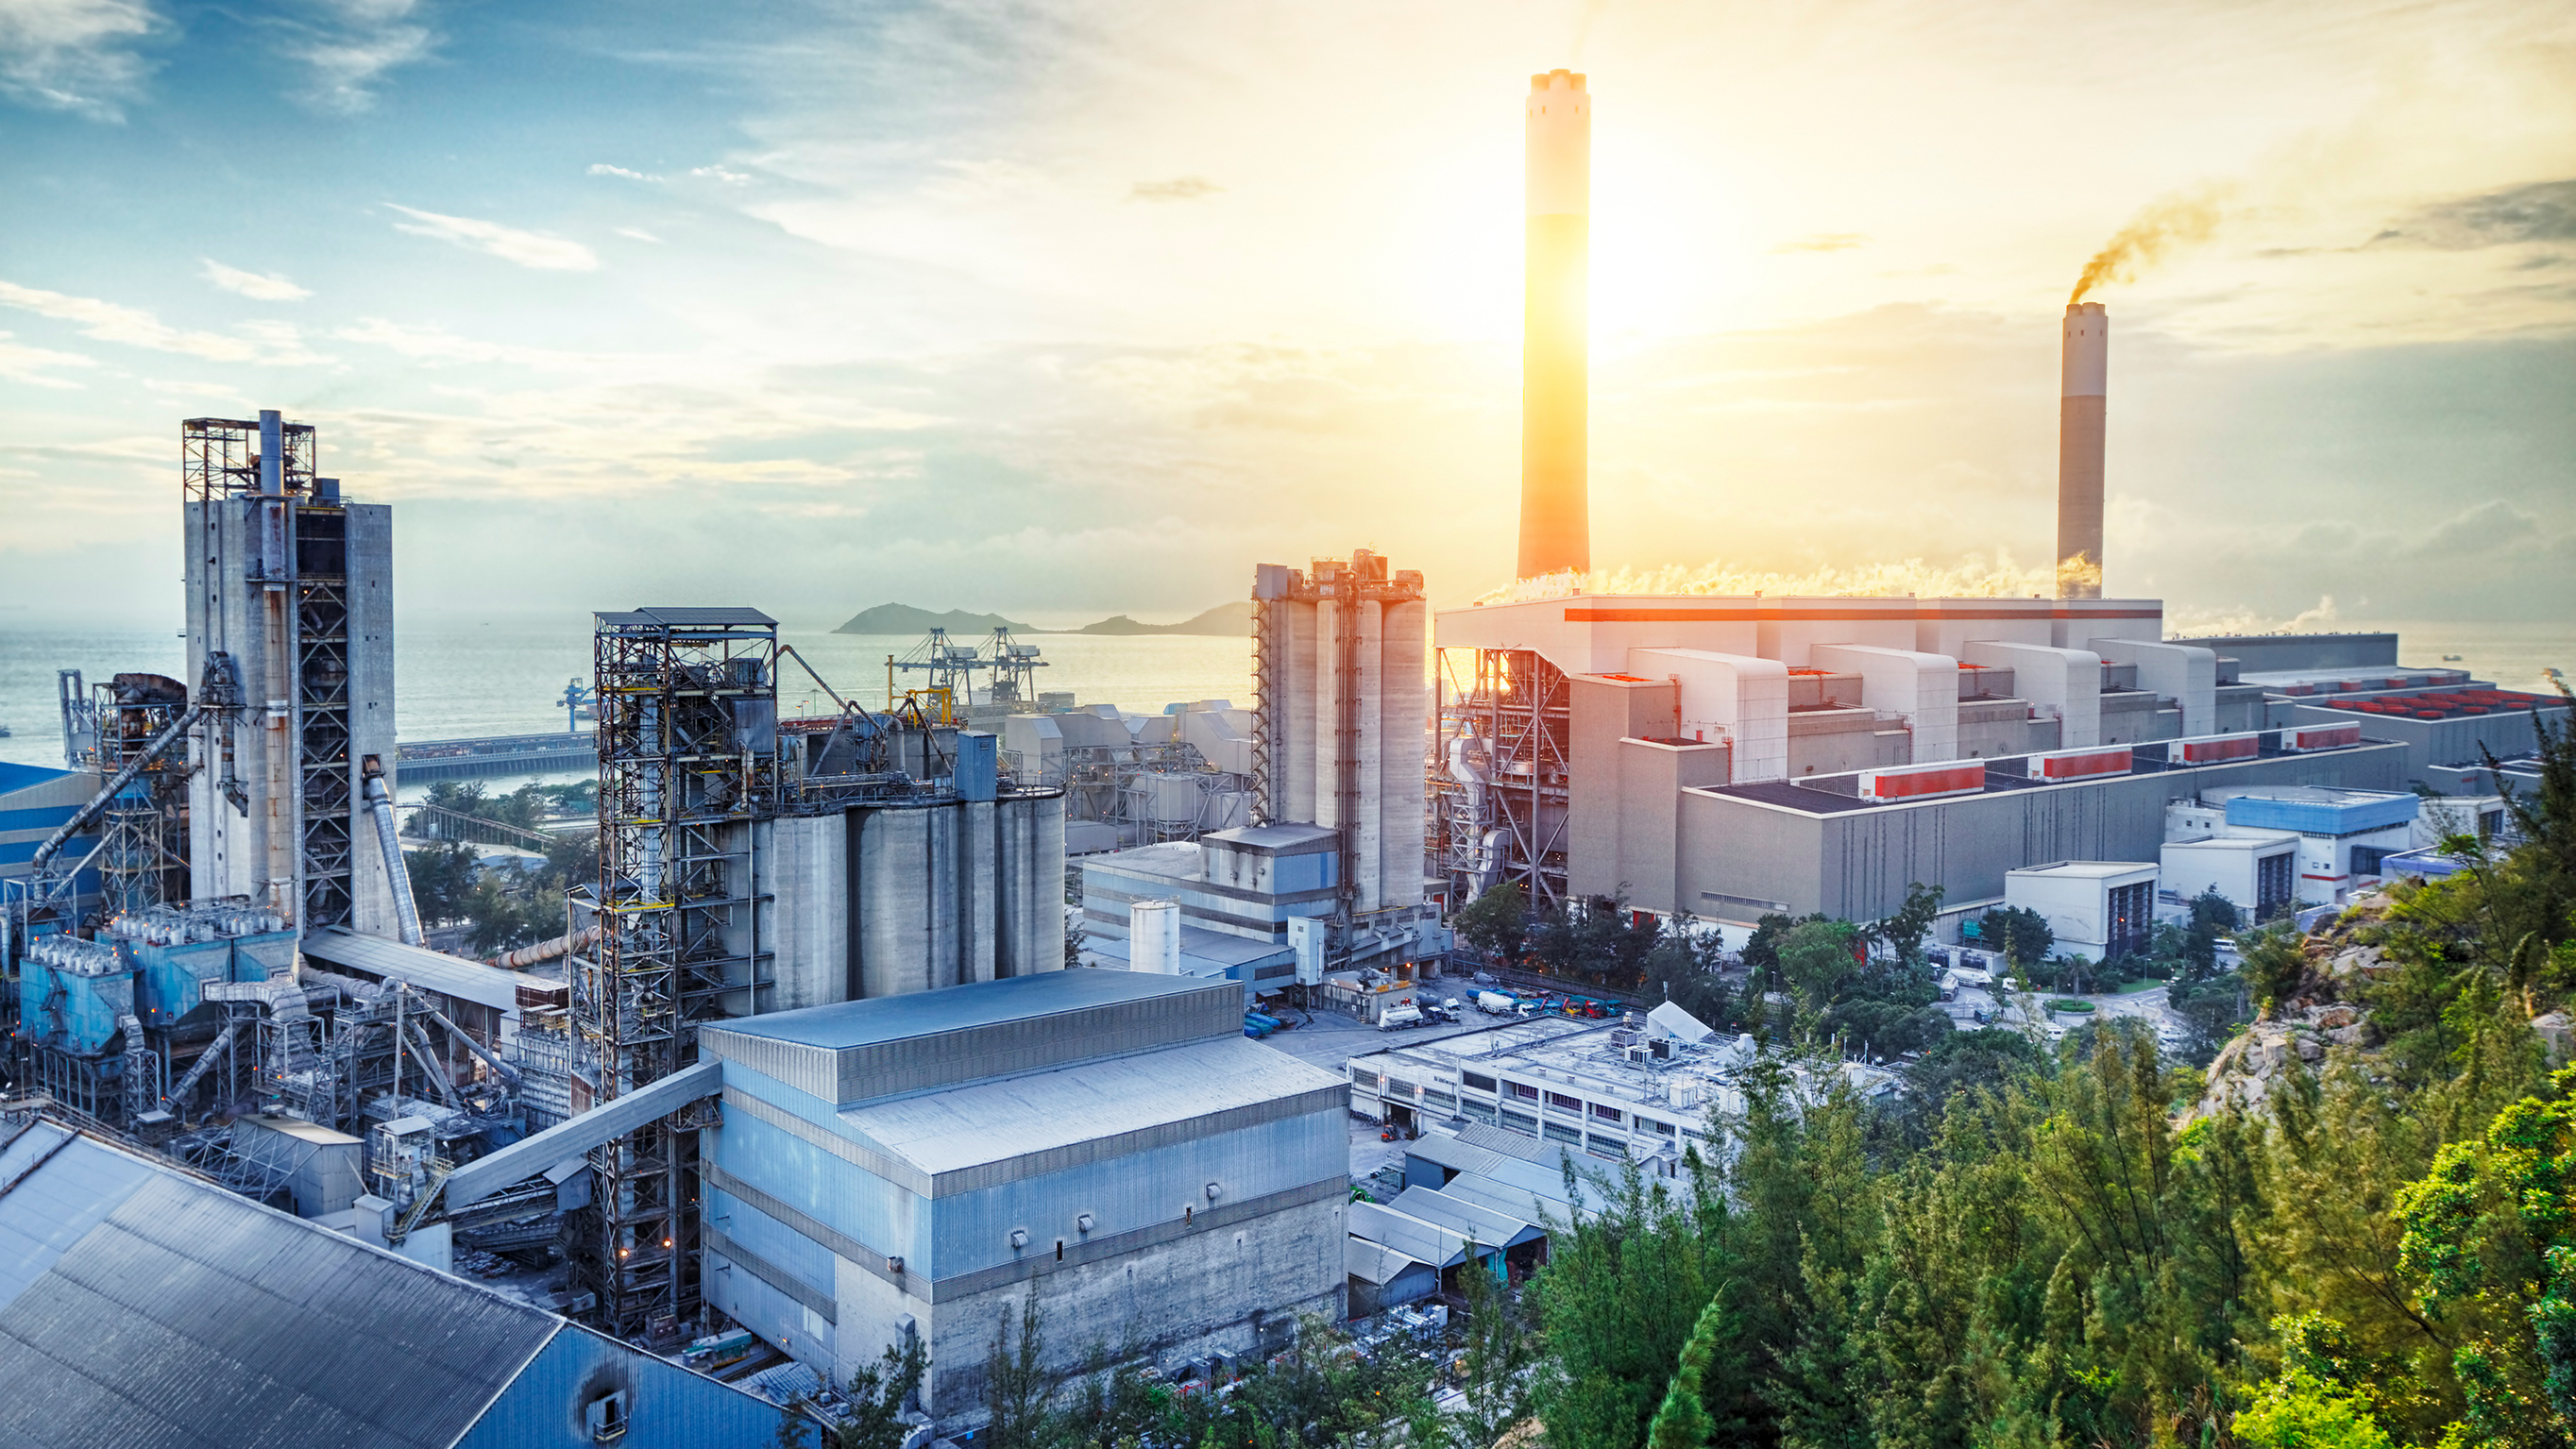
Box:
567;607;781;1339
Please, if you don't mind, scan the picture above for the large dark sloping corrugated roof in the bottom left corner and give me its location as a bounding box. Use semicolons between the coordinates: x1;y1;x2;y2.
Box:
0;1137;562;1449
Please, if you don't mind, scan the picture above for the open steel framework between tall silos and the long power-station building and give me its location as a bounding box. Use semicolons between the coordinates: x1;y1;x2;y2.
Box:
1427;649;1571;908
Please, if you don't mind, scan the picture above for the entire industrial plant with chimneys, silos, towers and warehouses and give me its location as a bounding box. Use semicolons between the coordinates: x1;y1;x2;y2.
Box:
0;56;2563;1449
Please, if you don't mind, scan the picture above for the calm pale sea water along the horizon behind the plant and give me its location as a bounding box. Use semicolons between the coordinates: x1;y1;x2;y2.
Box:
0;617;2576;767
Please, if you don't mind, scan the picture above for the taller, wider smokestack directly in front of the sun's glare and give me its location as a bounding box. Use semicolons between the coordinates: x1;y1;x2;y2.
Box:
1517;70;1592;579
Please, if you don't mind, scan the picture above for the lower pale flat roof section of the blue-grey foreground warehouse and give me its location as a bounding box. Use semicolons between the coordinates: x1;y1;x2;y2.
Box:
839;1035;1347;1176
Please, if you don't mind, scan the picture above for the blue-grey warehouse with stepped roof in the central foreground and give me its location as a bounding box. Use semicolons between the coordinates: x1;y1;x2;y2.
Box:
698;970;1349;1425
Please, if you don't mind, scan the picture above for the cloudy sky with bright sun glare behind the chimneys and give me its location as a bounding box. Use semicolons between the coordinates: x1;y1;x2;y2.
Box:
0;0;2576;628
